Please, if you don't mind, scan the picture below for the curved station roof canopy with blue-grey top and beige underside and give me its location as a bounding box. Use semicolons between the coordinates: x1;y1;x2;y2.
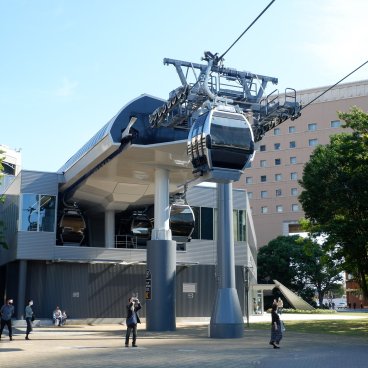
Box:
58;95;193;211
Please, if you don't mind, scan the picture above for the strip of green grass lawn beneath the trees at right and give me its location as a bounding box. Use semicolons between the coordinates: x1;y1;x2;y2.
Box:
250;315;368;338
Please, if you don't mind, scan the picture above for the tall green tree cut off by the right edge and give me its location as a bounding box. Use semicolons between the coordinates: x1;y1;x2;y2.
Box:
299;107;368;297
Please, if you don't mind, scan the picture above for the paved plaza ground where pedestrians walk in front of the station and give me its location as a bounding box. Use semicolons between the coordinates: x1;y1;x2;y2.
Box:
0;315;368;368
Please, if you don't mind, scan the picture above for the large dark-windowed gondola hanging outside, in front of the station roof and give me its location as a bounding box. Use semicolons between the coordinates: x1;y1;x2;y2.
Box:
187;105;254;182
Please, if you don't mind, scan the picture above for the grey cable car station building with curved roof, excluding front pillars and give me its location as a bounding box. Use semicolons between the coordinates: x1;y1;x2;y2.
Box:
0;95;262;321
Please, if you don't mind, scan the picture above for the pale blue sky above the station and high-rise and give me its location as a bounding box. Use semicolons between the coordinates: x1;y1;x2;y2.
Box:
0;0;368;171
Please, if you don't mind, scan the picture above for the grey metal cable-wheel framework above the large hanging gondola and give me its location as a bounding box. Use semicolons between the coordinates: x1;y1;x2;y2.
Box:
150;52;301;142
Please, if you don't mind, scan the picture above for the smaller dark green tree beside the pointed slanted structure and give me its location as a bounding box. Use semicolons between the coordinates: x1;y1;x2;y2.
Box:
257;236;341;304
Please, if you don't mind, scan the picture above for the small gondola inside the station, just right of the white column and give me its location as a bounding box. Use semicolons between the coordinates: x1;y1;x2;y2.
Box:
170;203;195;243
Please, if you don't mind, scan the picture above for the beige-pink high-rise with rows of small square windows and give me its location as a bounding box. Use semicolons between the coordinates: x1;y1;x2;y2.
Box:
234;80;368;247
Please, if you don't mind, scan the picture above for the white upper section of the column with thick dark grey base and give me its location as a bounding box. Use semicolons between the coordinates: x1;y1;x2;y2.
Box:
151;168;172;240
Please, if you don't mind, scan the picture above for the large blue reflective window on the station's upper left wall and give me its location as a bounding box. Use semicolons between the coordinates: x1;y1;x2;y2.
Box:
20;194;56;232
